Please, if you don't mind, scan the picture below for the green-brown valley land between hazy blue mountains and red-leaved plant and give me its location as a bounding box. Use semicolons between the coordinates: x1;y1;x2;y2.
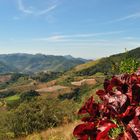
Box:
0;48;140;140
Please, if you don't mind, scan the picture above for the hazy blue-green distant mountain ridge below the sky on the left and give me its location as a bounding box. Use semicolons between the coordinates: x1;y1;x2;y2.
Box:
0;53;87;73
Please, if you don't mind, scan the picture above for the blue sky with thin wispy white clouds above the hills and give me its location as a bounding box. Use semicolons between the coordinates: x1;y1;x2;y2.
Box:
0;0;140;59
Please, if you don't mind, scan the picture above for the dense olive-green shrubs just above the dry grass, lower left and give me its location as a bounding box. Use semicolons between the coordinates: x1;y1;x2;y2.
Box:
0;98;76;136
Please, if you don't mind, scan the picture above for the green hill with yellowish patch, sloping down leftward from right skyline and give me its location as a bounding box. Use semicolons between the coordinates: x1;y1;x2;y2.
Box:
57;47;140;85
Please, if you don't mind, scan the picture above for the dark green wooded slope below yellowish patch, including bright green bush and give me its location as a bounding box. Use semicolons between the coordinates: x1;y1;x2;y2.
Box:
76;47;140;76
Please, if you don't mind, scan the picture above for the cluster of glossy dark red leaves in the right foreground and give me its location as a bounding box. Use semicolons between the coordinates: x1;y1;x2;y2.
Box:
73;74;140;140
